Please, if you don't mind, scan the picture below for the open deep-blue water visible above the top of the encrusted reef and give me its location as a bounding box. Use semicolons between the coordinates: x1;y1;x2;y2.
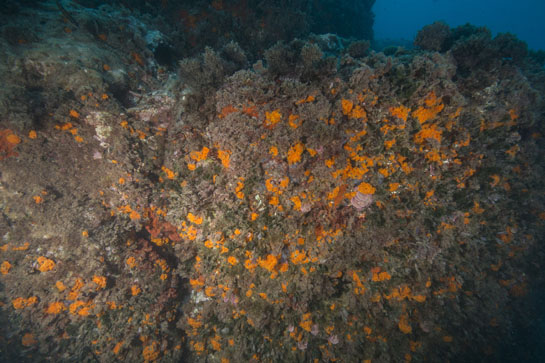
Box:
373;0;545;50
